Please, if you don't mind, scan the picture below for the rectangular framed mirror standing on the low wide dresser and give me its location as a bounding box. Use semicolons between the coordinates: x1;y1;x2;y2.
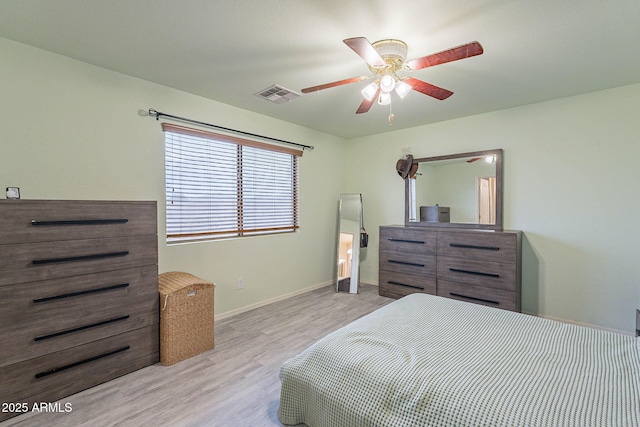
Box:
405;149;502;230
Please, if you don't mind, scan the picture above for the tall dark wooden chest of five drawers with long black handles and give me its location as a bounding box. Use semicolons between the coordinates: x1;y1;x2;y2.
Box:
0;200;159;420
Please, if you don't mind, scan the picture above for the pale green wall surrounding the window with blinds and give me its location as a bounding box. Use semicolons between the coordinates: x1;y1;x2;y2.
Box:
0;39;344;314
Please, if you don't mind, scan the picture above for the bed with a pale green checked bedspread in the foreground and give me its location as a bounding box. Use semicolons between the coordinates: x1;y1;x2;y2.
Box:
278;294;640;427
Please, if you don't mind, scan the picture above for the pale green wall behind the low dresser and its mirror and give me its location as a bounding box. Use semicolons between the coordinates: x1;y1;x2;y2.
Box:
347;84;640;333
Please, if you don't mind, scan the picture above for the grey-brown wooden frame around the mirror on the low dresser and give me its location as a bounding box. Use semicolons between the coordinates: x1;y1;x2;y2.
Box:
404;148;503;231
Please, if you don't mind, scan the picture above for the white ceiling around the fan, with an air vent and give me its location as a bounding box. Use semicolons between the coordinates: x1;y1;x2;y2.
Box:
0;0;640;138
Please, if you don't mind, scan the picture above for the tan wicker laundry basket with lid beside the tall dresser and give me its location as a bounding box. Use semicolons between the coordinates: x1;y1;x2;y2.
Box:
158;271;215;365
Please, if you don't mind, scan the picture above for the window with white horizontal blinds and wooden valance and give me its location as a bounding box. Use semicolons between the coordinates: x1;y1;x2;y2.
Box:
163;123;302;243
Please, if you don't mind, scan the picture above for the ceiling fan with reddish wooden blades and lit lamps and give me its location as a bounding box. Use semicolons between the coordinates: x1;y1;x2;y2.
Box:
302;37;483;116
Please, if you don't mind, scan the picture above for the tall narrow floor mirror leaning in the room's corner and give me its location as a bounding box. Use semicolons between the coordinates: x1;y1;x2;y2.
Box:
336;194;362;294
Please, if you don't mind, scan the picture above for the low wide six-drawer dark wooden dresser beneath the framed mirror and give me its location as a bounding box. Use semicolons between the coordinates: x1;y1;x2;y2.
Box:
379;226;522;311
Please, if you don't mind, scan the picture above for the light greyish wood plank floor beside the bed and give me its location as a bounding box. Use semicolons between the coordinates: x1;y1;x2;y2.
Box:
5;285;393;427
